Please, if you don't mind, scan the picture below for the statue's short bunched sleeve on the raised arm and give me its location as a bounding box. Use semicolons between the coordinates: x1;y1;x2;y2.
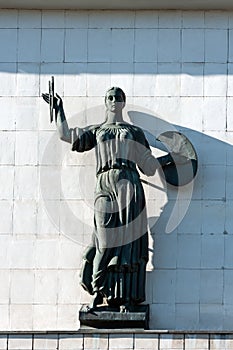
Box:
71;126;96;152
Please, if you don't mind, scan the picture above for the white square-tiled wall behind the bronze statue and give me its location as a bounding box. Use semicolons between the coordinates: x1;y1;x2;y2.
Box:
0;10;233;330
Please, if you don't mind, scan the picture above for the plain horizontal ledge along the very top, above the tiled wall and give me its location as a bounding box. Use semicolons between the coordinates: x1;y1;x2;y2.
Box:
0;0;233;10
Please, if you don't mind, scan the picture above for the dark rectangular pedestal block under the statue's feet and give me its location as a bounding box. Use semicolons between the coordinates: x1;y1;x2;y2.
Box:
79;305;149;329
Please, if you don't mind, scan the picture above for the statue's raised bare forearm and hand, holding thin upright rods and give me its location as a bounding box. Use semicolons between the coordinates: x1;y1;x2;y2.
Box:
42;94;71;143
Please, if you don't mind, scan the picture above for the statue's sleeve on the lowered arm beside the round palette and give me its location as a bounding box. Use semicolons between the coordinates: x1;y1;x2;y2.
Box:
135;128;158;176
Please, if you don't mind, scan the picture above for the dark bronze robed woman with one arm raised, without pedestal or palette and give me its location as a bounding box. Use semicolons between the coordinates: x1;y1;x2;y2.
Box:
43;87;176;309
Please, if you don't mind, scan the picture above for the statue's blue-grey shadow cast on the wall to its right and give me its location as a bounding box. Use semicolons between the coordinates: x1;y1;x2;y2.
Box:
128;111;233;329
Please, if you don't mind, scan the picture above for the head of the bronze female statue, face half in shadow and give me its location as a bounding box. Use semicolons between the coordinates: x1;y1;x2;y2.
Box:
105;86;126;112
